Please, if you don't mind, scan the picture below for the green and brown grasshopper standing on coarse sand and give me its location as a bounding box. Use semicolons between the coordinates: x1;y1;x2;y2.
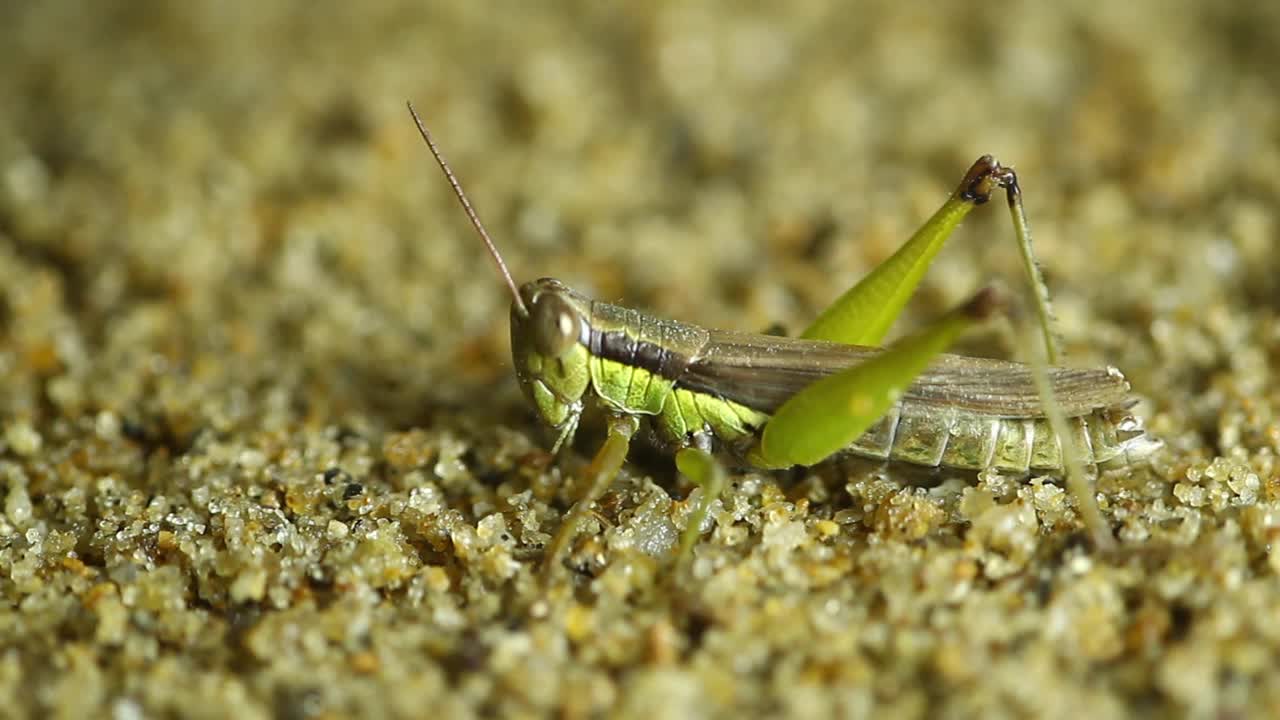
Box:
408;104;1160;570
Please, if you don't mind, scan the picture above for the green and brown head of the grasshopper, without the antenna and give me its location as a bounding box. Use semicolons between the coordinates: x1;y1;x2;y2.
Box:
511;278;591;452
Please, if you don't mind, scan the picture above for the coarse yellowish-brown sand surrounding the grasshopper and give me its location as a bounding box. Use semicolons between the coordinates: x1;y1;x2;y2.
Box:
0;0;1280;720
